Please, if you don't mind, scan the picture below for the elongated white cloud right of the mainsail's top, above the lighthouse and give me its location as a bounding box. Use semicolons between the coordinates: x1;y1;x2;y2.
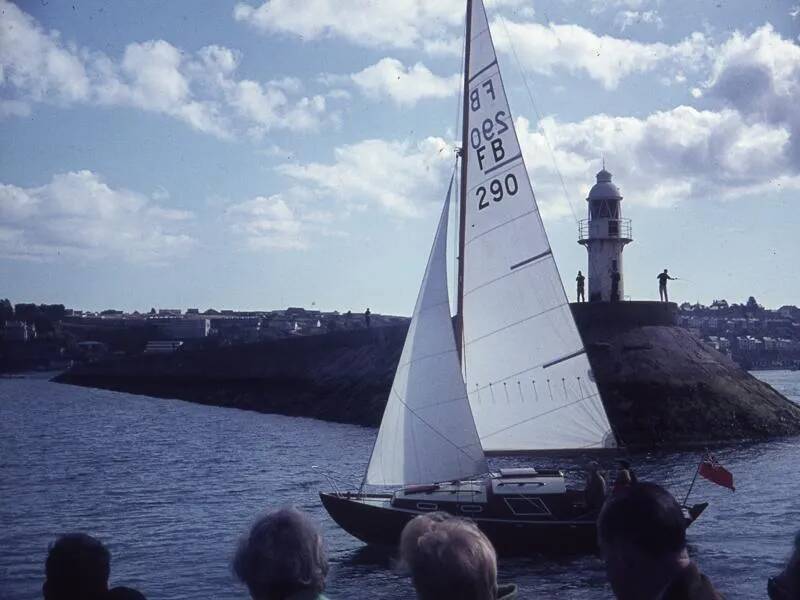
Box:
492;20;709;89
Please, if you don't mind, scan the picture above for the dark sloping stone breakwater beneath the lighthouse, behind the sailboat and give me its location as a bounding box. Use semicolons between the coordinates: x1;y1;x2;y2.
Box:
57;310;800;448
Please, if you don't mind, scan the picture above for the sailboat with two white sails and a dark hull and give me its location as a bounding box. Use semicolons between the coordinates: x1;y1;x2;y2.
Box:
320;0;704;553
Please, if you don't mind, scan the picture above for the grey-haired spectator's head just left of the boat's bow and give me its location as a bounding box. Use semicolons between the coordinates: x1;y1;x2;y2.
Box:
233;508;328;600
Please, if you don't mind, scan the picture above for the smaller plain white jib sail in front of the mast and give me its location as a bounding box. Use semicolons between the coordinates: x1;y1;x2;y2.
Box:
366;179;488;485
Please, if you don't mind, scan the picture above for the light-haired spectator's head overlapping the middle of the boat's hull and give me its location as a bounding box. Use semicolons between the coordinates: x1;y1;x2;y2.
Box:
400;514;516;600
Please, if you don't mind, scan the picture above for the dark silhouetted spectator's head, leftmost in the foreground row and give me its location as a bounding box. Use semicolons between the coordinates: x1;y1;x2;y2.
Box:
42;533;111;600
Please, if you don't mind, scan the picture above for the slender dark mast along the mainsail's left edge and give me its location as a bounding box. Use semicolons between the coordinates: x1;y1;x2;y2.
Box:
455;0;472;360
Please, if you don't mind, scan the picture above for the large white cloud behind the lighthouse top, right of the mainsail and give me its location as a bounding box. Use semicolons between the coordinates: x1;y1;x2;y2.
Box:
517;106;800;217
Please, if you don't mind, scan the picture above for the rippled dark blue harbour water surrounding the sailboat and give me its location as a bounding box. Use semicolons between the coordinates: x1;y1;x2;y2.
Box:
0;372;800;600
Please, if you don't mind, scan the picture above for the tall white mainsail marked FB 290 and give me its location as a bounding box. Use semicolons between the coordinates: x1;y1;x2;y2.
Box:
463;0;614;451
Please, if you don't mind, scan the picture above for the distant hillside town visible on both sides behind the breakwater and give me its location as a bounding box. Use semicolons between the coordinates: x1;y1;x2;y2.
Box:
0;296;800;371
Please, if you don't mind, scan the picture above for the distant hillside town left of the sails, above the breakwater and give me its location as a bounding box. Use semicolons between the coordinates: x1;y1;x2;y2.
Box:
0;299;408;371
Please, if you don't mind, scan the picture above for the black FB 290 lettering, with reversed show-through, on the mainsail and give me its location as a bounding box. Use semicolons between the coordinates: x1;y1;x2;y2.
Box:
469;78;519;210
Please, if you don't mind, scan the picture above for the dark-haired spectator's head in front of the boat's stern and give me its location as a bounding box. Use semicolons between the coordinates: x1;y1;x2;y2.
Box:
597;483;720;600
